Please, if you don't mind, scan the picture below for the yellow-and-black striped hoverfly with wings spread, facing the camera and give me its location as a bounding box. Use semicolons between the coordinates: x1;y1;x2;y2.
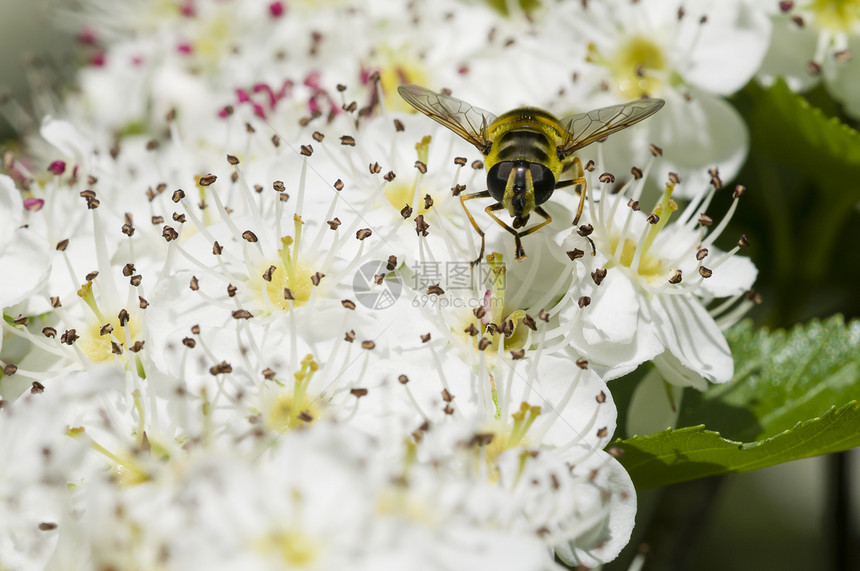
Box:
397;84;665;266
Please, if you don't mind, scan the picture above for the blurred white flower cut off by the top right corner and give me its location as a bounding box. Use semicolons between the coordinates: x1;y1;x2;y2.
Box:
759;0;860;117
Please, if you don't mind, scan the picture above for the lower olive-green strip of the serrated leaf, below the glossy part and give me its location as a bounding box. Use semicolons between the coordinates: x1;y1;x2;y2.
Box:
613;401;860;490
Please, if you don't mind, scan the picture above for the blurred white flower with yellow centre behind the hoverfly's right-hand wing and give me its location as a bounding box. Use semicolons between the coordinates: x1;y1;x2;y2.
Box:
548;0;770;197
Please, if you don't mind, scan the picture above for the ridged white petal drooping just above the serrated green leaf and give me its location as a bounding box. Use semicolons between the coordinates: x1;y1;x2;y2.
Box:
652;295;734;384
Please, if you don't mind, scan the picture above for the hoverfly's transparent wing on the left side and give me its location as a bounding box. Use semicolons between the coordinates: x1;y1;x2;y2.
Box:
397;84;496;152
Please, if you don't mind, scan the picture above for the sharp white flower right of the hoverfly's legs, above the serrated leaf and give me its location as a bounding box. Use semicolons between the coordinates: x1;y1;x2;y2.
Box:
561;159;756;389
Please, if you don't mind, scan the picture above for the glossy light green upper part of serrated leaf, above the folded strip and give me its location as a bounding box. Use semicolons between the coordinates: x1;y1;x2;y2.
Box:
678;315;860;442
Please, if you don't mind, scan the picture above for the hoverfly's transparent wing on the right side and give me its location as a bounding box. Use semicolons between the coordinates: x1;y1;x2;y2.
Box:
560;99;666;156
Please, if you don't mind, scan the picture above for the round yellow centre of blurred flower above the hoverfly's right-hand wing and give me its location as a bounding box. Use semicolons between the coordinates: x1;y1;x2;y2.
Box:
608;36;667;99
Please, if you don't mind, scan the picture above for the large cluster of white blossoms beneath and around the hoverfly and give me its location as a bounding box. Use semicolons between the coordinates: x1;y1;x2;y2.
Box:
0;0;769;569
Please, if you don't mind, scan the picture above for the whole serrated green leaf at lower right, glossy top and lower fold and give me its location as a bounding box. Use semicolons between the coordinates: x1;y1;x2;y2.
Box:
615;315;860;488
